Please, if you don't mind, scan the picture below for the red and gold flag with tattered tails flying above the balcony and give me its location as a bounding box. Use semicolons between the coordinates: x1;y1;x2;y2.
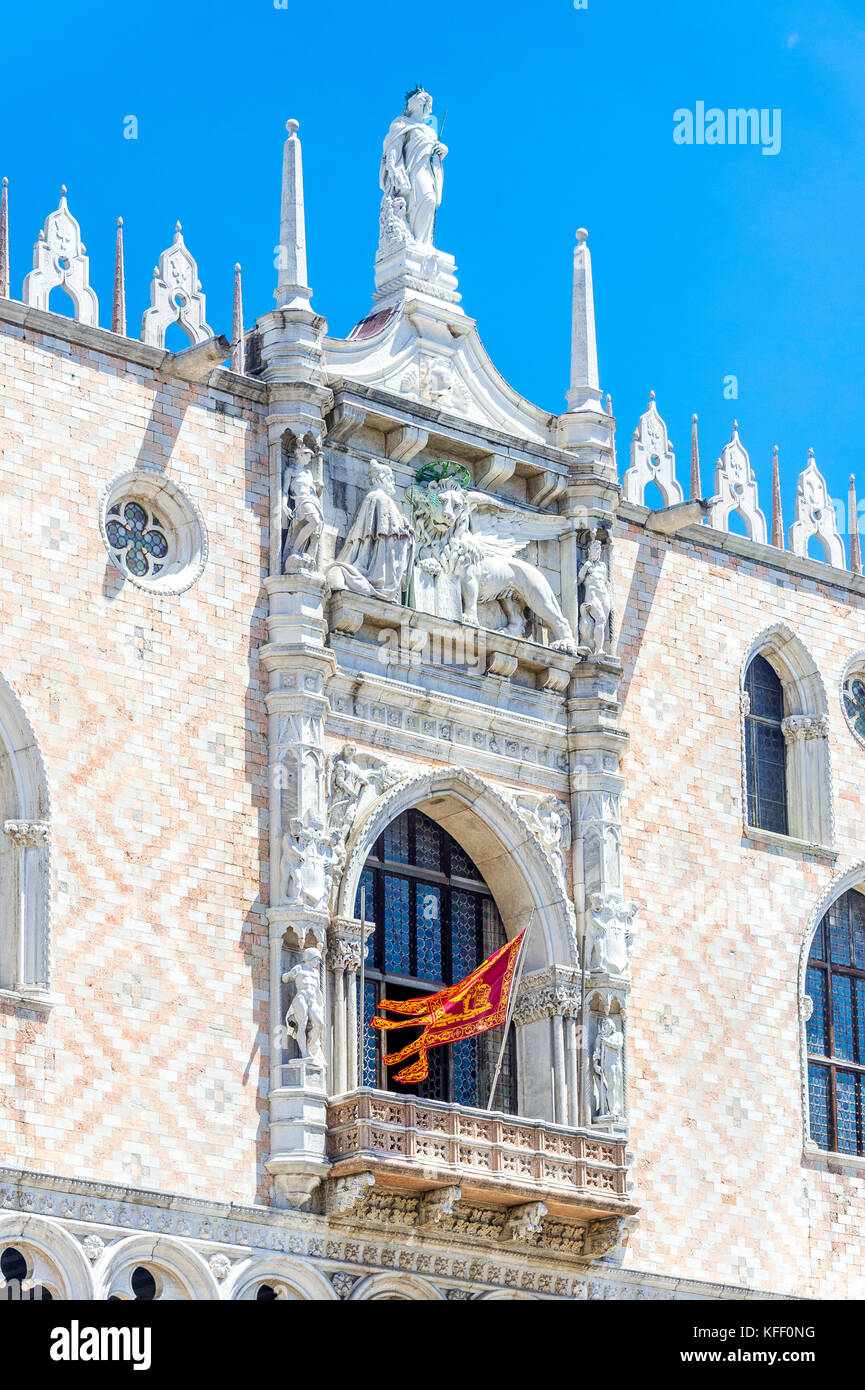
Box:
370;931;526;1083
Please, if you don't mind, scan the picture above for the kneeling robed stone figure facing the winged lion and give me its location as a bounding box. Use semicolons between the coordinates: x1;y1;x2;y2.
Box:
327;459;414;603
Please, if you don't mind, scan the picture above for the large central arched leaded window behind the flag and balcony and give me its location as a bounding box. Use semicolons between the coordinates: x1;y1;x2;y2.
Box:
355;810;517;1113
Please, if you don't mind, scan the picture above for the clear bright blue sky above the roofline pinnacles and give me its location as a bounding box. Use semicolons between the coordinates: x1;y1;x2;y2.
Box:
0;0;865;544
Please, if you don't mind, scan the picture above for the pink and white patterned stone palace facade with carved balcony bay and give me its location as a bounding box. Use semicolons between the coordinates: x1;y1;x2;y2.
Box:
0;90;865;1301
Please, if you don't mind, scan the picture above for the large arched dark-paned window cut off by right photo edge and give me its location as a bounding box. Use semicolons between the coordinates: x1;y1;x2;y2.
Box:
805;890;865;1155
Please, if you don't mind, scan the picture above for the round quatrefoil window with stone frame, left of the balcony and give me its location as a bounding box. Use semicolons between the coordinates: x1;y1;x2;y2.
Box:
99;468;207;594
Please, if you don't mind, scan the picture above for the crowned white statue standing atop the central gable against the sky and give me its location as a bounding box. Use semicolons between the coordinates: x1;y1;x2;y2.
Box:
378;86;448;246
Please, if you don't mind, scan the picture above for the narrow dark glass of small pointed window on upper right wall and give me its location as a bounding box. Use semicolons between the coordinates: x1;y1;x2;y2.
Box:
745;656;789;835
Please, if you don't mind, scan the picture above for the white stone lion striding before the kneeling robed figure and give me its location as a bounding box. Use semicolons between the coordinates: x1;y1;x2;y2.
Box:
407;466;577;655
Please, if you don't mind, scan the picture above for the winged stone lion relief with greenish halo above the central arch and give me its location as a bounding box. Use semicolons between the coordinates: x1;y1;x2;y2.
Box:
407;459;577;656
